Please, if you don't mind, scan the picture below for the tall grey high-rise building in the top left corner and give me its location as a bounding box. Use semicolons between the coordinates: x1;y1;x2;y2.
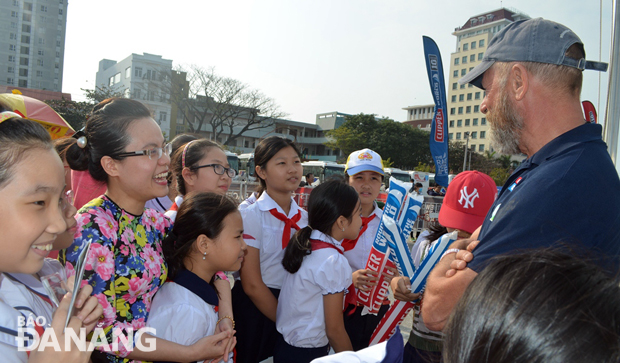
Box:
0;0;68;91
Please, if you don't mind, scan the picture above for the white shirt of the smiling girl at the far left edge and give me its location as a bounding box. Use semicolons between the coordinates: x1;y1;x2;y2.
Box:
0;274;40;363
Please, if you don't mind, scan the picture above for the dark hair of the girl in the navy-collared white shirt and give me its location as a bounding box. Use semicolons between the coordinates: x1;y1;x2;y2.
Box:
162;192;238;279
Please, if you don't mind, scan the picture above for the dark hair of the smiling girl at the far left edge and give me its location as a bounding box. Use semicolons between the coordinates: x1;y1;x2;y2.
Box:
0;117;52;187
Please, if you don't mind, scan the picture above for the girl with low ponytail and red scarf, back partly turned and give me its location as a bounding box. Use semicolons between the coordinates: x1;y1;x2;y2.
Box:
273;180;362;363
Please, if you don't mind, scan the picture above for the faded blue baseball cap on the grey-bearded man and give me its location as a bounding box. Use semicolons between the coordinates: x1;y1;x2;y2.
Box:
459;18;607;89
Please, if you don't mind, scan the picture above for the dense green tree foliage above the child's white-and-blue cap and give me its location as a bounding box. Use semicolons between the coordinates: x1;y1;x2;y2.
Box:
326;113;432;170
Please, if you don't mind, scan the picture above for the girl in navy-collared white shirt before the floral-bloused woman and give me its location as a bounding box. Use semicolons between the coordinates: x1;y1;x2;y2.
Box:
147;192;246;361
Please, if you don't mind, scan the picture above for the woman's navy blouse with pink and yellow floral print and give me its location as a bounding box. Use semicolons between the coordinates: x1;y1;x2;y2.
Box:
60;195;172;362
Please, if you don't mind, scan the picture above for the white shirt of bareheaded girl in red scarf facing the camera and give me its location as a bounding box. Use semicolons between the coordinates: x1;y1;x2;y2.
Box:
240;192;308;289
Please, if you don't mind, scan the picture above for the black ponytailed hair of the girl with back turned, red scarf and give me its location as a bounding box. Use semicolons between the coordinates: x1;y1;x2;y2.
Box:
282;179;359;274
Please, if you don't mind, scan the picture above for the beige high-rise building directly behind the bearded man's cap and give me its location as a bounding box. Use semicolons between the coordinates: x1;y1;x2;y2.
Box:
446;8;530;153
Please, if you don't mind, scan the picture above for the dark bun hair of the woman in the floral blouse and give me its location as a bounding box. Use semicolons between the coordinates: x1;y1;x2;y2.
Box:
66;98;151;182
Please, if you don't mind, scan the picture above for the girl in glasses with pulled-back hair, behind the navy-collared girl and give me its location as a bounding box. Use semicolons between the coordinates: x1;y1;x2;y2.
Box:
165;139;236;358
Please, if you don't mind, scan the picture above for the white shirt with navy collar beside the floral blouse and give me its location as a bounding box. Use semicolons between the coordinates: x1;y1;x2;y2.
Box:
146;270;232;362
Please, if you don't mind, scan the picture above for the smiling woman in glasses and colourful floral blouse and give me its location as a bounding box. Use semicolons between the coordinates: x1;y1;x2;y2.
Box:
60;98;232;363
